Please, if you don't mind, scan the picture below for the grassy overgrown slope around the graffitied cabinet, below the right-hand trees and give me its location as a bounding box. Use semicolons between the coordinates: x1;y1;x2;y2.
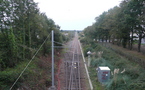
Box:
82;44;145;90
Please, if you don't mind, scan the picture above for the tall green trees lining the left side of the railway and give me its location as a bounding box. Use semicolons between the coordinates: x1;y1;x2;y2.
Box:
0;0;64;71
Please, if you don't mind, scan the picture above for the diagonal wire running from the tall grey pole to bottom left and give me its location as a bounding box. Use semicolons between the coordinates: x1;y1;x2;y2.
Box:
9;33;51;90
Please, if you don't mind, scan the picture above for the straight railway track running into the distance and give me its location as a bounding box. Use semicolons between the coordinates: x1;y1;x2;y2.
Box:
64;33;83;90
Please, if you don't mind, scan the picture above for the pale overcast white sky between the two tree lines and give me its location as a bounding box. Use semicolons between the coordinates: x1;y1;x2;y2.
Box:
34;0;122;30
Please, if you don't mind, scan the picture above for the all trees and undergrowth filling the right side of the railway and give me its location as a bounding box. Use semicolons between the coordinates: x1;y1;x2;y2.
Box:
80;0;145;90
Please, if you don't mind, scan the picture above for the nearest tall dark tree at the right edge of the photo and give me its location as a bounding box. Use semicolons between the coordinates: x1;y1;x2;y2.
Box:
127;0;145;52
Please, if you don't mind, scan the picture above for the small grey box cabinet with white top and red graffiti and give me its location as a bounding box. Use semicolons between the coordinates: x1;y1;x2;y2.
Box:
96;67;110;83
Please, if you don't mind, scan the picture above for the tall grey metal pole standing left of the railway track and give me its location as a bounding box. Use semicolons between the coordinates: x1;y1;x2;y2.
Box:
52;30;54;87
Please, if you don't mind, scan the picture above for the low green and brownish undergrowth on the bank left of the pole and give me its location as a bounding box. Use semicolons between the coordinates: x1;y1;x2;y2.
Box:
0;58;51;90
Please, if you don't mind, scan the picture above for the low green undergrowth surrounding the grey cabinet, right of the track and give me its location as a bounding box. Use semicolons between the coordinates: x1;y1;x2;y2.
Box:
80;34;145;90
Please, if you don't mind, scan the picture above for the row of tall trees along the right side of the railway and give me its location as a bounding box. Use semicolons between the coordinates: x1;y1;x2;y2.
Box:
84;0;145;52
